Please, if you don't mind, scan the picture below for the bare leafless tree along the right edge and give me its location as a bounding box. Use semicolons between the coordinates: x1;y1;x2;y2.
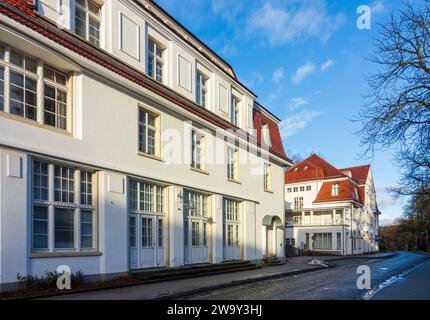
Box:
358;0;430;195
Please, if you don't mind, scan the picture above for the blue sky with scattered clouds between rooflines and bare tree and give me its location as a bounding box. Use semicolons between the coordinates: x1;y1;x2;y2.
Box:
157;0;403;224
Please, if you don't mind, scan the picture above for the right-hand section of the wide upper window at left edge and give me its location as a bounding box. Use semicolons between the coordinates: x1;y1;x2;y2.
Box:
43;67;67;130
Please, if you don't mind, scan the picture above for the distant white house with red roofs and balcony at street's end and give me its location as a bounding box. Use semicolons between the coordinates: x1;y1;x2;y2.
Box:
285;154;380;255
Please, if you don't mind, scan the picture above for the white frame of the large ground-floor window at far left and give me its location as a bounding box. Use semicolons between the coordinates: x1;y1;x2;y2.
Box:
30;157;98;255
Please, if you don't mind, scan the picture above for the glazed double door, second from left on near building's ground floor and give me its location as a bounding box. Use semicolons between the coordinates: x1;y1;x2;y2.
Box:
184;218;209;264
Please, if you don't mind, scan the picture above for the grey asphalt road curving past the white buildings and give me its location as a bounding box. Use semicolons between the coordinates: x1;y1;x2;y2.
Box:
186;252;430;300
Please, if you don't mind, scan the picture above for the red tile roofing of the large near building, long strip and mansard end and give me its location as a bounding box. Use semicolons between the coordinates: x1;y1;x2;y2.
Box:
0;0;289;161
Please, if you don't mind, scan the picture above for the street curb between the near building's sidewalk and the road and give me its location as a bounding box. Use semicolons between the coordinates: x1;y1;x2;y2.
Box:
155;267;335;300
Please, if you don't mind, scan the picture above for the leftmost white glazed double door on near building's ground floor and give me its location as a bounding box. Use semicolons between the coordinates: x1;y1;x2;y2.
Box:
129;214;166;269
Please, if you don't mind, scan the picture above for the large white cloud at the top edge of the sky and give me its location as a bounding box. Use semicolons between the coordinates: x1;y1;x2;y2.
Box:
247;0;345;46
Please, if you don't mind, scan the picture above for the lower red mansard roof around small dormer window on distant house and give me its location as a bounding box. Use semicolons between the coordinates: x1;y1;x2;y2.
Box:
314;180;362;203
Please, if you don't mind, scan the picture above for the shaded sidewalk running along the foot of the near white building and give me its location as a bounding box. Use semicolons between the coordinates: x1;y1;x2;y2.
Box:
40;254;392;300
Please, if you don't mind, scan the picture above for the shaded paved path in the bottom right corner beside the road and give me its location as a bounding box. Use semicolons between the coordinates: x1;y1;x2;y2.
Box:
372;260;430;300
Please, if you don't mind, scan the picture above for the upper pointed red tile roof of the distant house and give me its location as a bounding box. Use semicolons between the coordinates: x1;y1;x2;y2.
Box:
285;154;347;183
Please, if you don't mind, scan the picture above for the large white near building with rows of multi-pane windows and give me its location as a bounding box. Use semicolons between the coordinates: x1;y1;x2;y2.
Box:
0;0;290;284
